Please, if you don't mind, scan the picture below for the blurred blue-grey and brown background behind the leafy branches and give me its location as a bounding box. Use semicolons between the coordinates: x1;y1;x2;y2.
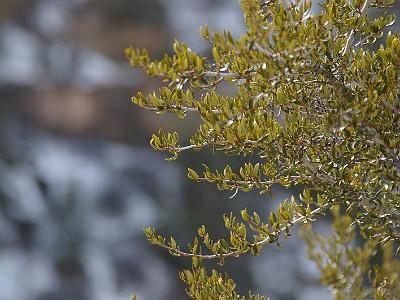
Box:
0;0;398;300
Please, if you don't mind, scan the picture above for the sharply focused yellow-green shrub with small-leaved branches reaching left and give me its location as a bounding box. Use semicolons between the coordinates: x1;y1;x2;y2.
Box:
126;0;400;299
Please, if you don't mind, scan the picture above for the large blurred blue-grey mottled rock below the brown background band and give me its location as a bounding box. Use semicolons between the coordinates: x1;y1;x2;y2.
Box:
0;128;182;300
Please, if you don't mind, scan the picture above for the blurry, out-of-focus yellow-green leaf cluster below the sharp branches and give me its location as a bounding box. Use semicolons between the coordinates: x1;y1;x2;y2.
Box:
302;206;400;300
